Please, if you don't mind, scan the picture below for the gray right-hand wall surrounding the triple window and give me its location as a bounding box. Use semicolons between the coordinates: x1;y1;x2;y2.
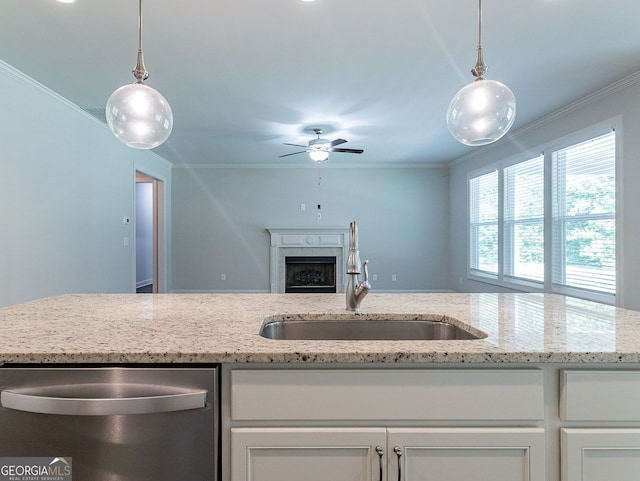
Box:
449;73;640;309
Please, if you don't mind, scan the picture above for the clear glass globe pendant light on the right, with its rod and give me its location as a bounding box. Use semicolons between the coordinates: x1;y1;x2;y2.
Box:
447;0;516;146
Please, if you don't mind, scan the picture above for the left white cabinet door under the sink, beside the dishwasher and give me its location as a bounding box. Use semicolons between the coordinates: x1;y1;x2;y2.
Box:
231;428;386;481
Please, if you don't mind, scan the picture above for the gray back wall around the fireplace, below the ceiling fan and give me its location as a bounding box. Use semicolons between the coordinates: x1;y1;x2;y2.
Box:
172;165;450;292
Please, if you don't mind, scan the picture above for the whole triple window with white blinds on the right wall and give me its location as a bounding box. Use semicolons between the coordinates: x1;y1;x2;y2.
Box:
469;128;616;303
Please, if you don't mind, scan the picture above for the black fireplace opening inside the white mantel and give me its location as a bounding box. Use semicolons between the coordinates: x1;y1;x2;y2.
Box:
285;256;337;293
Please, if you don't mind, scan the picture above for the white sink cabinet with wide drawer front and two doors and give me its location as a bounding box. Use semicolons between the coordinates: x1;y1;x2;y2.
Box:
228;369;545;481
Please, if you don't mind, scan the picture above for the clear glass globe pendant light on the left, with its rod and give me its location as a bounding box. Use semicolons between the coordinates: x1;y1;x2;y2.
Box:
106;0;173;149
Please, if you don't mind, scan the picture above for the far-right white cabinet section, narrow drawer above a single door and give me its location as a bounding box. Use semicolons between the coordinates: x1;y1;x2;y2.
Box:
560;370;640;481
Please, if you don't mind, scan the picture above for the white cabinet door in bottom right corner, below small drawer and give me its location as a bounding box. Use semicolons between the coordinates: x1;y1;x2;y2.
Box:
561;429;640;481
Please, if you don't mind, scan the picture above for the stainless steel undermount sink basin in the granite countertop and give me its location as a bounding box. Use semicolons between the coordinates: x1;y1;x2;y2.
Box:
260;317;487;341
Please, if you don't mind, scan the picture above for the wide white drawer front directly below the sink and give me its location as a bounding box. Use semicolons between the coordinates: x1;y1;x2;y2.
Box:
231;369;544;421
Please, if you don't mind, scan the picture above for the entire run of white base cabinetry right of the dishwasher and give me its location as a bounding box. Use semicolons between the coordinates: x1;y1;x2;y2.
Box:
223;363;640;481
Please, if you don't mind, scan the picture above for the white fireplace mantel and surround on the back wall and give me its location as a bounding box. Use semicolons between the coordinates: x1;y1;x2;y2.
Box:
267;228;349;293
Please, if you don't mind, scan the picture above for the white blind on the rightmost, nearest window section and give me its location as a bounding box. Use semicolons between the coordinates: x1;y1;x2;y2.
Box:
552;132;616;294
